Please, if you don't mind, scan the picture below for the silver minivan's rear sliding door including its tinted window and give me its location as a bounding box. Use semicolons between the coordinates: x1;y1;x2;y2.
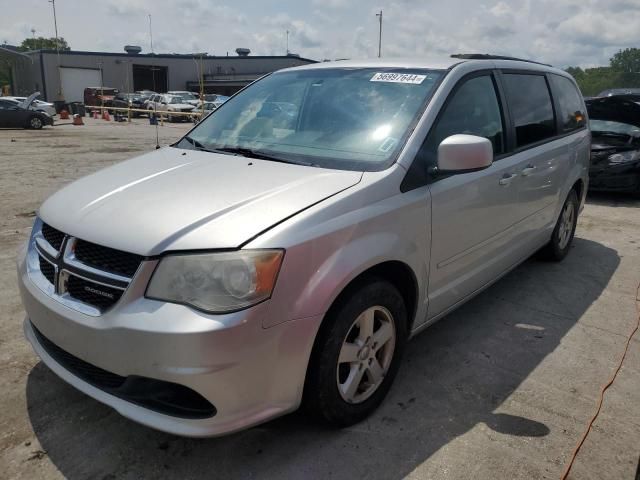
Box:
501;71;568;235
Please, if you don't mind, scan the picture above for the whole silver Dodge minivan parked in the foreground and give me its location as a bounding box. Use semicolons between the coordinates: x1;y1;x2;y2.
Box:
18;55;590;436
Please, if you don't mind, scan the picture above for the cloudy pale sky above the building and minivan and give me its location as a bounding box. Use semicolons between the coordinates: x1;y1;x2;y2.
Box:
0;0;640;67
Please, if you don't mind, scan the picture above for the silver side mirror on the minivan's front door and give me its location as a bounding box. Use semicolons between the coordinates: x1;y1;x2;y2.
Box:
438;134;493;173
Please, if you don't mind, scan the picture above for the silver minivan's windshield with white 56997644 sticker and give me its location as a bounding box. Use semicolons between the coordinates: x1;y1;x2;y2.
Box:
175;68;444;171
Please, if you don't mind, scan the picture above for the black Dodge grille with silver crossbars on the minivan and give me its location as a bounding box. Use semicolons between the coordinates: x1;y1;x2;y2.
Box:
27;219;144;316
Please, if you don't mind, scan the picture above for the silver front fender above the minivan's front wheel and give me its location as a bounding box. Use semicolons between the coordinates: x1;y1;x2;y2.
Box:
263;191;430;328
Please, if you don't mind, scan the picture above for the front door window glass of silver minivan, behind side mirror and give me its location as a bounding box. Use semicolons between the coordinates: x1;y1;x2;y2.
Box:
423;75;504;161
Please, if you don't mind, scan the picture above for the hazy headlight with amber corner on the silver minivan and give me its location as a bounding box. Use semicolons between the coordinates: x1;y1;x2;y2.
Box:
146;250;284;313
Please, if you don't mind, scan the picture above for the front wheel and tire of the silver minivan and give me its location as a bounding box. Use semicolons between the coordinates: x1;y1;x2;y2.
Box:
303;278;407;427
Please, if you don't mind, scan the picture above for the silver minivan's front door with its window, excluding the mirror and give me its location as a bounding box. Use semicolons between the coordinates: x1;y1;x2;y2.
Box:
416;72;519;318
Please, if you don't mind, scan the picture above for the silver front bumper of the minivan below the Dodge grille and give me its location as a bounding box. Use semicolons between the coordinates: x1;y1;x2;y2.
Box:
18;246;321;437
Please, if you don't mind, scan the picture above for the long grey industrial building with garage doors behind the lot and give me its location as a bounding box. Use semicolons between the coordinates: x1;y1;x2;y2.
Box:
0;46;314;102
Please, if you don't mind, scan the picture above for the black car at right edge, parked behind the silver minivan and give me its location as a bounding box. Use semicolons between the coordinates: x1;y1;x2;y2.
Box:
586;94;640;194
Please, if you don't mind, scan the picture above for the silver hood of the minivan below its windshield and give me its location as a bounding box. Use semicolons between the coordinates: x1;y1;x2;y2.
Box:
39;147;362;255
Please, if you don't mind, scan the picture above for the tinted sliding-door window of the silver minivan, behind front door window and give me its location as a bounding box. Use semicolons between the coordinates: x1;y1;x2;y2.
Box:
502;73;556;148
